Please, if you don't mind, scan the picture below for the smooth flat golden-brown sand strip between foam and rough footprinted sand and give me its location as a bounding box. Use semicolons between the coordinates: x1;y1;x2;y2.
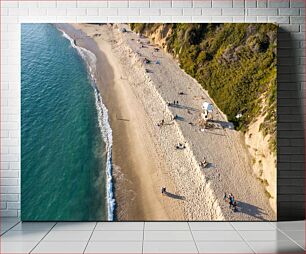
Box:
60;24;182;221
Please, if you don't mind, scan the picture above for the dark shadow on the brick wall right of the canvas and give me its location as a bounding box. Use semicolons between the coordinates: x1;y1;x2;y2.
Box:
277;28;305;220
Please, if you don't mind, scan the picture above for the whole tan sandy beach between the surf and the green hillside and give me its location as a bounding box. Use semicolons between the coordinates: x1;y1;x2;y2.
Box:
68;24;276;221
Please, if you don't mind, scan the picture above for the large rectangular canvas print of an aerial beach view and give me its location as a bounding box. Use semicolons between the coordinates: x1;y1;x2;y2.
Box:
21;23;277;221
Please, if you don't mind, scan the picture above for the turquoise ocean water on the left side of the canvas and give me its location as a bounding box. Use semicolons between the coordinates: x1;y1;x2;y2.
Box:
21;24;113;221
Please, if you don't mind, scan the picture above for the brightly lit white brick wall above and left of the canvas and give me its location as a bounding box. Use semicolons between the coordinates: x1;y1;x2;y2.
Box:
0;0;305;216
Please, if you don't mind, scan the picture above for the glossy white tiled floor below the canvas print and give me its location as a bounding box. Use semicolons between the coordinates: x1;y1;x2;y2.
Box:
0;218;305;253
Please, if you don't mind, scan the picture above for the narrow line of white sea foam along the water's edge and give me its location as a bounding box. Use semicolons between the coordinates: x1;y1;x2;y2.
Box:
59;29;116;221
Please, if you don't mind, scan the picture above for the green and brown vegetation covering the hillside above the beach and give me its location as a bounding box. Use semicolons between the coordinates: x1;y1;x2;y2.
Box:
131;24;277;151
